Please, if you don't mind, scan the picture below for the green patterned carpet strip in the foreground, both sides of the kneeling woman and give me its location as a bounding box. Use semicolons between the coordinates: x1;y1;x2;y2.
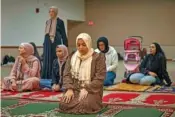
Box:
1;99;175;117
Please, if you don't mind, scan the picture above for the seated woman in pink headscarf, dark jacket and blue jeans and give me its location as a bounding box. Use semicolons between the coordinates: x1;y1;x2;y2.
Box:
40;45;68;91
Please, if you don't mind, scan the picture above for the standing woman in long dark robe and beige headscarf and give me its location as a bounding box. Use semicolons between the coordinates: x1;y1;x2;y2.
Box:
41;6;68;79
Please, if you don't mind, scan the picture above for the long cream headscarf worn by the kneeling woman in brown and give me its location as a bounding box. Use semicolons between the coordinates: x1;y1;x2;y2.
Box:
71;33;94;84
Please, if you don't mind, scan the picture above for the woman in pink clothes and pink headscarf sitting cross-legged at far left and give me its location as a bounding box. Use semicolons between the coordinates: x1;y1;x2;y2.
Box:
2;43;41;91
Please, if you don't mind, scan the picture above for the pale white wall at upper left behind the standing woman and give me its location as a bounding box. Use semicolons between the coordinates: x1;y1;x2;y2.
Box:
1;0;85;46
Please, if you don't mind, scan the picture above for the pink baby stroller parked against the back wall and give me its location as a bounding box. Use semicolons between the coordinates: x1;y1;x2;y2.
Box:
124;36;143;78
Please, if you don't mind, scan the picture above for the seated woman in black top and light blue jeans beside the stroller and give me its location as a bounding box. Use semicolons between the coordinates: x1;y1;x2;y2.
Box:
129;43;172;86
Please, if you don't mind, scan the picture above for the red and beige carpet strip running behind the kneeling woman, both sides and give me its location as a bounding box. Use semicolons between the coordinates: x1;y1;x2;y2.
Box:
1;91;175;107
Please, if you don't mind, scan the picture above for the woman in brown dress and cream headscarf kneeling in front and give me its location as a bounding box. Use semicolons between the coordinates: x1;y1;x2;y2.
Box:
59;33;106;114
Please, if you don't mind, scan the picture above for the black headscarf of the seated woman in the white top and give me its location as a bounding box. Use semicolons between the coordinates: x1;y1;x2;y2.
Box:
97;37;109;53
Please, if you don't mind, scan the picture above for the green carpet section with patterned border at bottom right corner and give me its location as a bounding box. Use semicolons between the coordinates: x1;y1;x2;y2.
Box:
104;104;175;117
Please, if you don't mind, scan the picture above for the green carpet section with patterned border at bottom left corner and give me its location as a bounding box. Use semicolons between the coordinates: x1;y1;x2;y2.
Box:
1;99;108;117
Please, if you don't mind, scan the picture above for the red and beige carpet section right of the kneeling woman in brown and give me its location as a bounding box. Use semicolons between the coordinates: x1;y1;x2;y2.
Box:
103;92;175;107
